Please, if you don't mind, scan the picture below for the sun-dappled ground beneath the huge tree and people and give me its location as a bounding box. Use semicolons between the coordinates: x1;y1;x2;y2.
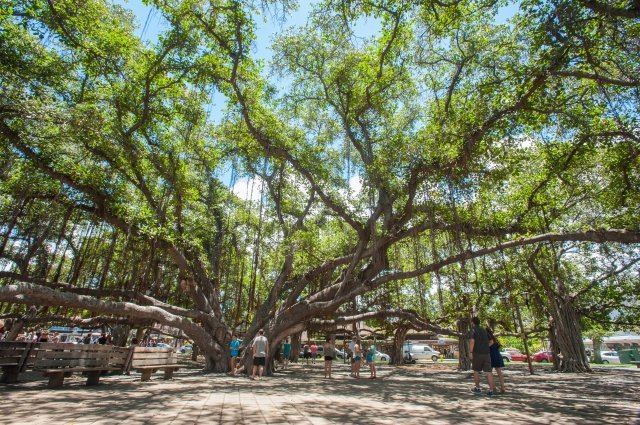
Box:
0;363;640;425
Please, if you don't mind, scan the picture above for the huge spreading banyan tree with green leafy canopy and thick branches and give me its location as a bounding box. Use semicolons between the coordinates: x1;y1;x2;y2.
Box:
0;0;640;370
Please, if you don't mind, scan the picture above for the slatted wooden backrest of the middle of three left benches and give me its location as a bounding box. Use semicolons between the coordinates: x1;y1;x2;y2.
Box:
33;342;113;369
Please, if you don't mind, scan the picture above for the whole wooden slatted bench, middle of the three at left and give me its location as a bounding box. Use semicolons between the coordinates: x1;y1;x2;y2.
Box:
33;342;130;388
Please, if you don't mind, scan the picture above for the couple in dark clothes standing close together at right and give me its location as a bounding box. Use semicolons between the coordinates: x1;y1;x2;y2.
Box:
469;317;505;397
